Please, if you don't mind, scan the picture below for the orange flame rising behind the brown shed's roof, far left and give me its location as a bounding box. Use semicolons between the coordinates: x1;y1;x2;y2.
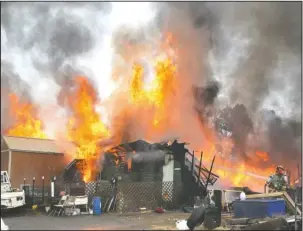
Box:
5;94;47;139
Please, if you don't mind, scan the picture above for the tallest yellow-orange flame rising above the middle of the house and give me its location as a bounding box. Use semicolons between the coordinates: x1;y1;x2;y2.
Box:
123;37;177;141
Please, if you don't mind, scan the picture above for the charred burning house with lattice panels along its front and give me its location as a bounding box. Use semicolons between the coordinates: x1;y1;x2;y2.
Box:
62;140;218;211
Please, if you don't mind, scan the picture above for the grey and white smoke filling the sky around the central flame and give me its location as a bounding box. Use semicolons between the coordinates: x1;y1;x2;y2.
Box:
1;2;302;177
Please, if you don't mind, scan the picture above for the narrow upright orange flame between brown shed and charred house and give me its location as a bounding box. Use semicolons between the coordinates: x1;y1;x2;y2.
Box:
67;77;110;182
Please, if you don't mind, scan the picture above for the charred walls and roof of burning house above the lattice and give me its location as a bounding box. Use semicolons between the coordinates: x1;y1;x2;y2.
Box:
62;140;219;204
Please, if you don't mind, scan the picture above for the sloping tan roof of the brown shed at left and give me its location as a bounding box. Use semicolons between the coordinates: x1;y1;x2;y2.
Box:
2;136;70;154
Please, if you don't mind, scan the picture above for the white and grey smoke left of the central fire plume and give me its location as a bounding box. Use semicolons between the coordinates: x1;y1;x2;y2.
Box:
1;2;162;135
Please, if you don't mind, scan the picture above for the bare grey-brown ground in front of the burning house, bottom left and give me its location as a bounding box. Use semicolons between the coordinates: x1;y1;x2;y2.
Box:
2;208;195;230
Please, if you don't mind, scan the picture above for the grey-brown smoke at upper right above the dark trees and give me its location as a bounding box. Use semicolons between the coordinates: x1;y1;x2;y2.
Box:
210;3;302;120
